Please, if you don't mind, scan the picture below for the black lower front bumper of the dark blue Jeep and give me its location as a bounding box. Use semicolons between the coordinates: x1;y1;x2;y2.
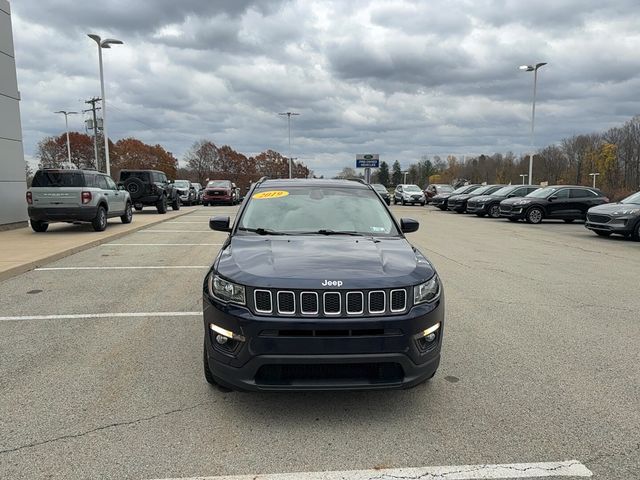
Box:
203;294;444;391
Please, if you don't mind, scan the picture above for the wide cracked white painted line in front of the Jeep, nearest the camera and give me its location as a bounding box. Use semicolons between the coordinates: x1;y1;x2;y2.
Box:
149;460;593;480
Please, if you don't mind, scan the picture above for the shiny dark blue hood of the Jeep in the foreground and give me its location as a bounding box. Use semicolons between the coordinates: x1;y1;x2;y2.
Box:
214;235;435;289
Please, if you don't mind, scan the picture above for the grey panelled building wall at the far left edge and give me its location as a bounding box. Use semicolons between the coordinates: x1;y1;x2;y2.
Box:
0;0;27;229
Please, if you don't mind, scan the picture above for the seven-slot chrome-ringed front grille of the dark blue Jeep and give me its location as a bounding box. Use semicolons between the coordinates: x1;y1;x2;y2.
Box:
250;288;410;317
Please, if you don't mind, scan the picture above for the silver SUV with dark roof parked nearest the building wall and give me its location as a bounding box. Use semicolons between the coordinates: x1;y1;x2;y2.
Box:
27;168;133;232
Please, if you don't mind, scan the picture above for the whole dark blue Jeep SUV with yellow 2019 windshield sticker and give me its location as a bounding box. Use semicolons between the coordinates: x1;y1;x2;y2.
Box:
203;180;444;390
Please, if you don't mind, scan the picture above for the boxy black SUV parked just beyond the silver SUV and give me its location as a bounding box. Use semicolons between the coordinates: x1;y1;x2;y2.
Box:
119;170;180;213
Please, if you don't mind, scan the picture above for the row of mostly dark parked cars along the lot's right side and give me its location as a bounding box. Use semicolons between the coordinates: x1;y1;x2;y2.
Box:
430;185;640;241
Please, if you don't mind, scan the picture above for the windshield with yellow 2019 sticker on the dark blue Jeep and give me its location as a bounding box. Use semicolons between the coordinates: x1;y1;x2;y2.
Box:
238;186;398;236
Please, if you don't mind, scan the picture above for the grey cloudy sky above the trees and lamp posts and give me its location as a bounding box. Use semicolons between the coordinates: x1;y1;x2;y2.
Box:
11;0;640;175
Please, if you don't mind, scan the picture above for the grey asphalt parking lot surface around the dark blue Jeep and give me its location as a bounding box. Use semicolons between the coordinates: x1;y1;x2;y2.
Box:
0;206;640;480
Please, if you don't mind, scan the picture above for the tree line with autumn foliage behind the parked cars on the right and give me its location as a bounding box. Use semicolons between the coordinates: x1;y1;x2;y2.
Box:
336;116;640;199
